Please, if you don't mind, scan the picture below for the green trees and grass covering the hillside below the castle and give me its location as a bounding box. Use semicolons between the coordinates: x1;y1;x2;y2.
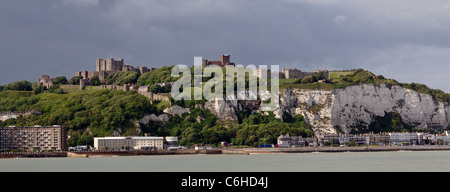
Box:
0;66;450;146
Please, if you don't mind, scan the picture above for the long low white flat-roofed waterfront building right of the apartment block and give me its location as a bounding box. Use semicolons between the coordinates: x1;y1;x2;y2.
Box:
94;137;164;150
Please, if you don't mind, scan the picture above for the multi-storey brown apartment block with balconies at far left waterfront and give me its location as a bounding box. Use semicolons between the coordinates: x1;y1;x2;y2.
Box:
0;125;67;151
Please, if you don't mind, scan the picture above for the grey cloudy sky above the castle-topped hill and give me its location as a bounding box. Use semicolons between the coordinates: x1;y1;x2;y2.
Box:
0;0;450;92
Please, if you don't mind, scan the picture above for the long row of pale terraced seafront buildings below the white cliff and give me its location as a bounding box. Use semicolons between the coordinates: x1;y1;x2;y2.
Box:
277;132;450;148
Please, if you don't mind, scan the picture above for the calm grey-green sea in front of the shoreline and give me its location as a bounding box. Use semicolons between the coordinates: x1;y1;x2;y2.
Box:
0;151;450;172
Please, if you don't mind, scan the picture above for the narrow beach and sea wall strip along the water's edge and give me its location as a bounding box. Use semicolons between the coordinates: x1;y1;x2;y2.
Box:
0;145;450;159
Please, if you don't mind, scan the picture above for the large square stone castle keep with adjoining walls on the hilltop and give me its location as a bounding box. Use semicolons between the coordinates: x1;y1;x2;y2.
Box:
75;58;154;82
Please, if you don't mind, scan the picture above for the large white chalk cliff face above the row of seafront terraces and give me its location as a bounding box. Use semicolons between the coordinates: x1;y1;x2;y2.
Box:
276;84;450;135
